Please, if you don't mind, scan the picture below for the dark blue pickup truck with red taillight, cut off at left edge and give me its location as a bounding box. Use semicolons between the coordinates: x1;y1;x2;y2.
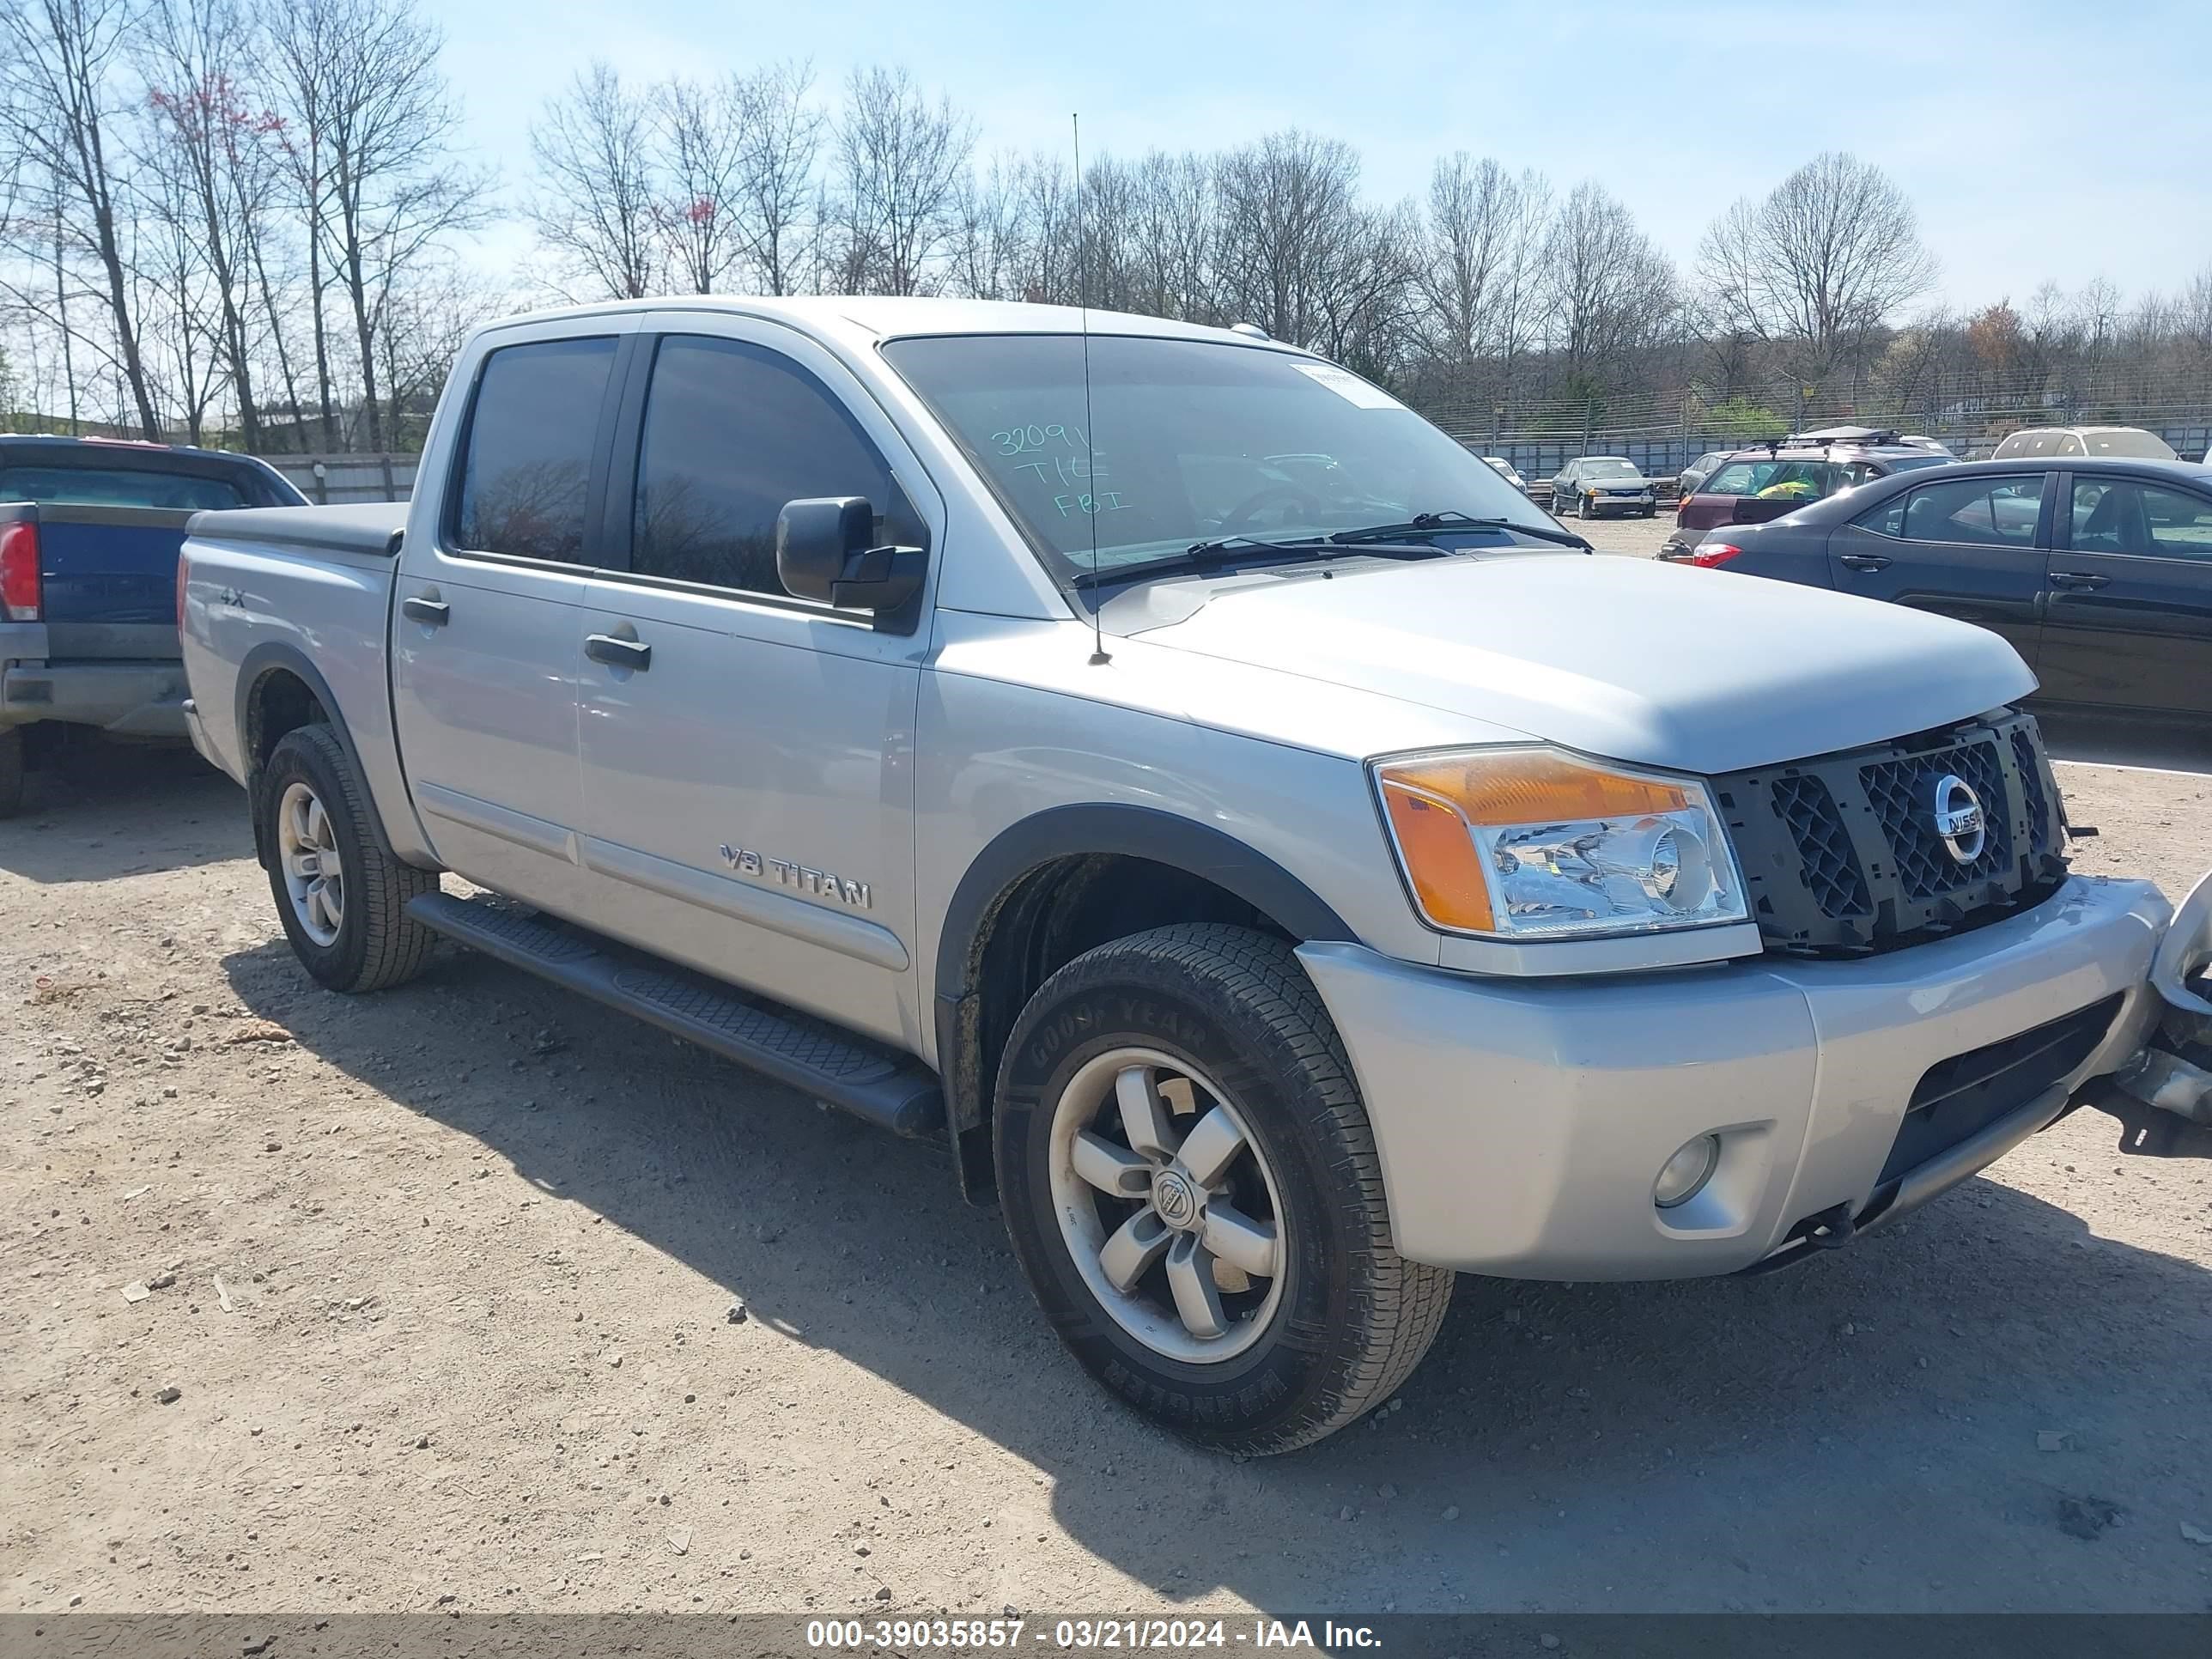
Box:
0;438;307;818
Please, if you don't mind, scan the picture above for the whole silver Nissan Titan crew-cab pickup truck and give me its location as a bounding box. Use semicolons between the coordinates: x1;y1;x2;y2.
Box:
184;299;2212;1453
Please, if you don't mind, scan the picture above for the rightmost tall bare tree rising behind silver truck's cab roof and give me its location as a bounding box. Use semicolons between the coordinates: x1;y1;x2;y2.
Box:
830;69;975;295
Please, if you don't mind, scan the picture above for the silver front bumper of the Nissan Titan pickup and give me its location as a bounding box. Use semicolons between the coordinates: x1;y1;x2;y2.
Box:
1298;876;2170;1279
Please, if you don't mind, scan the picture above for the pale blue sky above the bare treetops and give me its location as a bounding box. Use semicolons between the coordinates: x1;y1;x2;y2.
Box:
427;0;2212;305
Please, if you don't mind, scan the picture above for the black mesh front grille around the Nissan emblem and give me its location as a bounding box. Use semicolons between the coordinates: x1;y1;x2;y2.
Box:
1714;710;2066;956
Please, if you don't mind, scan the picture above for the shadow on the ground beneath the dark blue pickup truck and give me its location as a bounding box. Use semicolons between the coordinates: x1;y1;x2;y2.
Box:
0;744;252;884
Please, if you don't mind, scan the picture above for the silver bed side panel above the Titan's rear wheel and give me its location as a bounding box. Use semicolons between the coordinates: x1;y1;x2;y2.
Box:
181;502;427;858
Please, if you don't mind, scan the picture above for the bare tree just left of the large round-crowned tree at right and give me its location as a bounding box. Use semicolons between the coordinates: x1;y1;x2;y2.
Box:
1544;184;1679;380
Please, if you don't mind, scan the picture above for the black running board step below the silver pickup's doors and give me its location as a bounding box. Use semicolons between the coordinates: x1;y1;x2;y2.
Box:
407;894;945;1134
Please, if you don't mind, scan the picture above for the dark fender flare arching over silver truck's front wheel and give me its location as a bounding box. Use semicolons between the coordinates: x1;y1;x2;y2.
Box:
933;803;1358;1199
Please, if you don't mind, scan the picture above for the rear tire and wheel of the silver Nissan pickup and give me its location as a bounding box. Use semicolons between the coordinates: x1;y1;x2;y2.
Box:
258;726;438;991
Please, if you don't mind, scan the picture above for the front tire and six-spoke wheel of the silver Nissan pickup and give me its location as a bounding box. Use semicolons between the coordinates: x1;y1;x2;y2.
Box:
994;925;1453;1453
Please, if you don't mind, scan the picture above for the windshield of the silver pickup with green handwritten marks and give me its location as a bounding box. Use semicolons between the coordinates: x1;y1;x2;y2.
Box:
883;334;1548;580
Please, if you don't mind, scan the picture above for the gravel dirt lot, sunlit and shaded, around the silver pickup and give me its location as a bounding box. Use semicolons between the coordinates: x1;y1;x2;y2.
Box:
13;730;2212;1613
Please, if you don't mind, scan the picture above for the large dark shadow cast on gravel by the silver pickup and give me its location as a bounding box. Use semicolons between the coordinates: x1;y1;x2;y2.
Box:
223;940;2212;1610
